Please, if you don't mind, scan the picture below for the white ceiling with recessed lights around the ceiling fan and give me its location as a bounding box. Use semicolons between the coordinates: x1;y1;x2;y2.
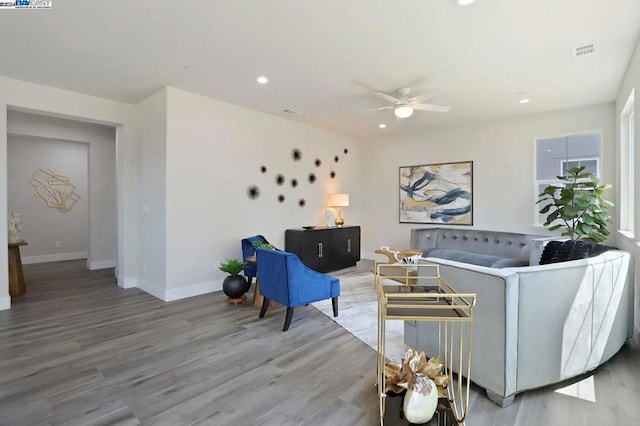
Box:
0;0;640;139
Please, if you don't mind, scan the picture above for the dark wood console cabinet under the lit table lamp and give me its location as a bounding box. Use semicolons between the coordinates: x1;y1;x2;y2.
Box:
284;226;360;272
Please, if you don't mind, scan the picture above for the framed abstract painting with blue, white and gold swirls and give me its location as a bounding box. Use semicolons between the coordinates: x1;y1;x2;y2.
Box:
400;161;473;225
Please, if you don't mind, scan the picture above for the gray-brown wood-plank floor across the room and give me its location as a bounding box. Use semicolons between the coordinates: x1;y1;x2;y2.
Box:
0;261;640;426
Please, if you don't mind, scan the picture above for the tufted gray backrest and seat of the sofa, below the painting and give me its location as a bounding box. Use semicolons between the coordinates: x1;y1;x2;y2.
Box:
411;228;555;268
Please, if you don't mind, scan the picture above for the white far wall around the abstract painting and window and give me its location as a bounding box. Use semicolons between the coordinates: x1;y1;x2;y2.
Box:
363;103;616;255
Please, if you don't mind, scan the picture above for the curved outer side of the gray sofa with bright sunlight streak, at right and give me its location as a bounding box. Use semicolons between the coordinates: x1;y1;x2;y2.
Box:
510;250;630;391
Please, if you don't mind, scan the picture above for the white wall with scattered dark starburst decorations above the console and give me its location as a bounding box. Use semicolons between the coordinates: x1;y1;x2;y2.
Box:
159;88;364;299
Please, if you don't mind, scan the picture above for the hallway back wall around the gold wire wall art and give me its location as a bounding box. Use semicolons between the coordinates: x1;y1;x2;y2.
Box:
7;134;90;264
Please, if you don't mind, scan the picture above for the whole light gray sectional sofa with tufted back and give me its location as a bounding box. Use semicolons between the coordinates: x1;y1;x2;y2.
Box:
404;228;633;407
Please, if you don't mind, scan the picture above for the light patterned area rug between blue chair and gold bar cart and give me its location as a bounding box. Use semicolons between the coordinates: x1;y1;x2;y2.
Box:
313;271;405;361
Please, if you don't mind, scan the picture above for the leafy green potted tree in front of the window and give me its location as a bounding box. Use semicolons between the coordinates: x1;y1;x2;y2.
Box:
537;167;613;243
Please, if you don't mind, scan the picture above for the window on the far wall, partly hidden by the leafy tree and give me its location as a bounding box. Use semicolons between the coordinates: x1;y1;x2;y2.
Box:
534;131;602;226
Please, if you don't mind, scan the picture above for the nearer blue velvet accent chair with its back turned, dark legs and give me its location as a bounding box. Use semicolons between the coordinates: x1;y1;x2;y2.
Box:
256;249;340;331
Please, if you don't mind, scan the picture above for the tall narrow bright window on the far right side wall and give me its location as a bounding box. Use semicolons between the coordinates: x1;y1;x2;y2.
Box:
620;91;635;233
